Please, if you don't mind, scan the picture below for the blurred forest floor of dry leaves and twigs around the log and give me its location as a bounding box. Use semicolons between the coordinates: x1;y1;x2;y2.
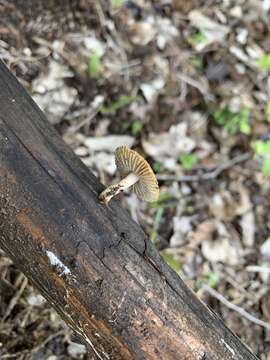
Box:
0;0;270;360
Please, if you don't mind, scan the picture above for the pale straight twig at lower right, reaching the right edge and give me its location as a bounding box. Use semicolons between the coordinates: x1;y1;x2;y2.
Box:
202;284;270;331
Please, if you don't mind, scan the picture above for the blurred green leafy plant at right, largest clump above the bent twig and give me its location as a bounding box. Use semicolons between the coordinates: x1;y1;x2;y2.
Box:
213;106;251;135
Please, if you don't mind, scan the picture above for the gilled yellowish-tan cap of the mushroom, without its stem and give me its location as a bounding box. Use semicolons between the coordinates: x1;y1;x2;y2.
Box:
115;146;159;202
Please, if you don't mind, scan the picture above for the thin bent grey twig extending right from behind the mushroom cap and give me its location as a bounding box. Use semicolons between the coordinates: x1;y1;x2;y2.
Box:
157;153;250;182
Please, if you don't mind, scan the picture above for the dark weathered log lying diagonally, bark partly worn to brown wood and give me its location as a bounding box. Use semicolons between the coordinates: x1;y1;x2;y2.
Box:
0;63;256;360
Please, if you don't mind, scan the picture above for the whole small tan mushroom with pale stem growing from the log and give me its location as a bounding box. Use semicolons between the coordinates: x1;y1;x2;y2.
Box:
99;146;159;204
